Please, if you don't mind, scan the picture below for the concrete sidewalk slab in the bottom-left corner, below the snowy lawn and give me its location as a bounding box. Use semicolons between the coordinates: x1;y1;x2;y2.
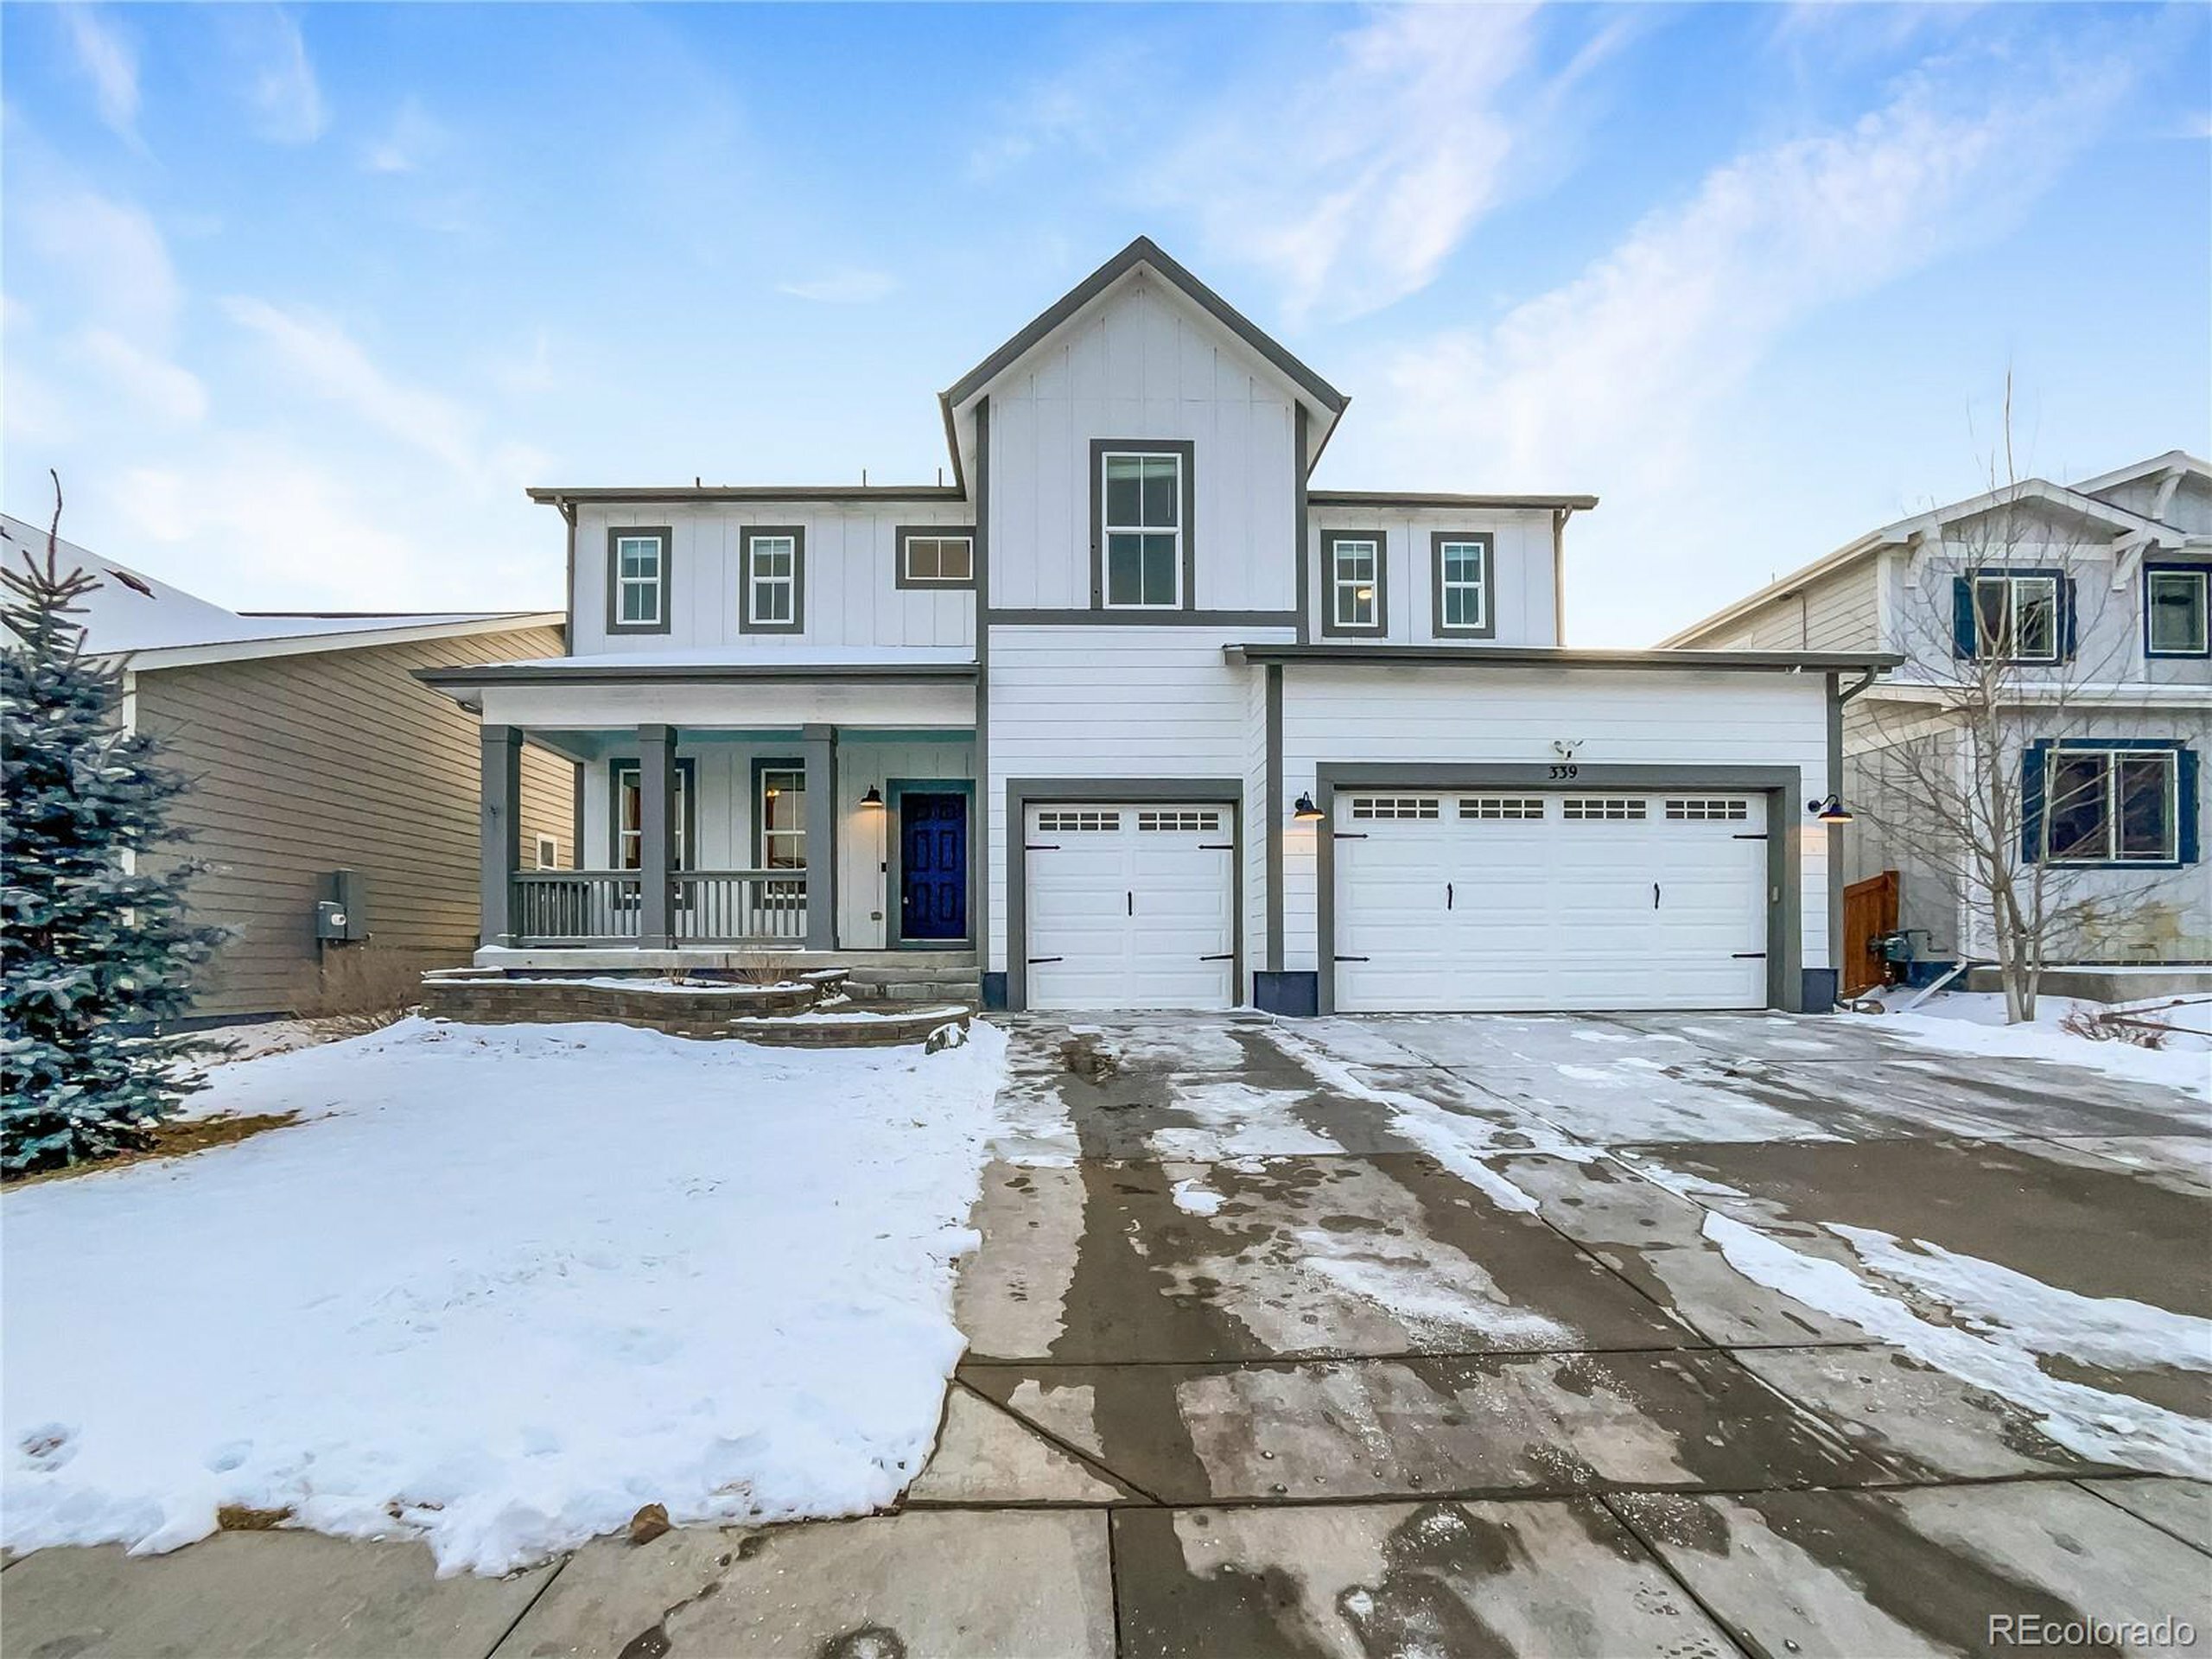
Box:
7;1531;553;1659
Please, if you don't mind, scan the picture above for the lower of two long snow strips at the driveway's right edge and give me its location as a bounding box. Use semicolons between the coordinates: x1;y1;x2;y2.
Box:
1706;1212;2212;1476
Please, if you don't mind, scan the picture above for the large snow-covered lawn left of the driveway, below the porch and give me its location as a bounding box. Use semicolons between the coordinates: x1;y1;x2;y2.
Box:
0;1020;1004;1573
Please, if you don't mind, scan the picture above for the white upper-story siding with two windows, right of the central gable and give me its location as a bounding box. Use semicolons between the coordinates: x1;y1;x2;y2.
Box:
1307;512;1560;646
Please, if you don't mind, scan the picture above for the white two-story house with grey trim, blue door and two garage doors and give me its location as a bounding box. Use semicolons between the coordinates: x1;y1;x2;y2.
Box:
425;238;1885;1011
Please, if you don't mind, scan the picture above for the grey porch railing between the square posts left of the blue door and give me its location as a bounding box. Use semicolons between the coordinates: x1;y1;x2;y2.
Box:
513;869;807;947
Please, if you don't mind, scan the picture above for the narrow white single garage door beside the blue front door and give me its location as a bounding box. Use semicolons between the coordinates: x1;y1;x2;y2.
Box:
1022;803;1236;1008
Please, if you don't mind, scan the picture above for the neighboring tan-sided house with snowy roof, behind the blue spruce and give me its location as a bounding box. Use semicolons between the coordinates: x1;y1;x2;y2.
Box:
0;515;577;1018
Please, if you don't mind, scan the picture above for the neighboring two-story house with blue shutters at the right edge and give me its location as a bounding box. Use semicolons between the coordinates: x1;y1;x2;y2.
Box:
1663;451;2212;963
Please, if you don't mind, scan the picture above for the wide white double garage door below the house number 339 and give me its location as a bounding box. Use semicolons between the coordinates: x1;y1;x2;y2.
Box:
1334;790;1767;1013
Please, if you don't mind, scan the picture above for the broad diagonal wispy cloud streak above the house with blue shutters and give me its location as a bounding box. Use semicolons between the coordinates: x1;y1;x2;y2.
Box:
1389;47;2130;493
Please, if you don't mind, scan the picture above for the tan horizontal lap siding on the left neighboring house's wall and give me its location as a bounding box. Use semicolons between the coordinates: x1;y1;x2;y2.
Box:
137;628;573;1013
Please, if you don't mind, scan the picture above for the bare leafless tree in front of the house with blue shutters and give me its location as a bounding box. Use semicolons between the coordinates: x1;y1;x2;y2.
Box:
1853;402;2181;1022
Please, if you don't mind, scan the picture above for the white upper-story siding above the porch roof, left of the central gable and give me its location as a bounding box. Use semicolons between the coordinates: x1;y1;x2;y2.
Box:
570;500;976;657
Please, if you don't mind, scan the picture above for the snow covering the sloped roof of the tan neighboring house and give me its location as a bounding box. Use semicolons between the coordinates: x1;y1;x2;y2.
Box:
0;513;553;655
